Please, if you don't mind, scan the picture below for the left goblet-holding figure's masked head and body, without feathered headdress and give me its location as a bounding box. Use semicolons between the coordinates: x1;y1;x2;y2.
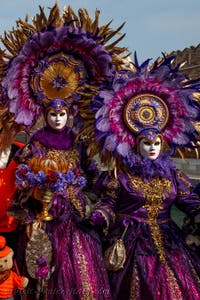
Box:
16;99;111;299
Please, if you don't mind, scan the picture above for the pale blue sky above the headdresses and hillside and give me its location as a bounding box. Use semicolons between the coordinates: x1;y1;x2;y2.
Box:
0;0;200;62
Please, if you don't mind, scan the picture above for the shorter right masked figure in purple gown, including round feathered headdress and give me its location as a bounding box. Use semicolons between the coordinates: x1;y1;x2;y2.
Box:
82;56;200;300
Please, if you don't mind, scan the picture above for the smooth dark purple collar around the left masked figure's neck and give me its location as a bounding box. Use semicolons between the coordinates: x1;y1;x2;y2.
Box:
30;127;74;150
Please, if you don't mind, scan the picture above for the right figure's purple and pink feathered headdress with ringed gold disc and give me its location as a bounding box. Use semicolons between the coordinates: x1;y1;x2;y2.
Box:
79;55;200;166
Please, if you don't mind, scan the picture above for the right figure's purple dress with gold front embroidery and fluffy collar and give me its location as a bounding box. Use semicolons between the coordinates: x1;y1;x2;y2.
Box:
98;155;200;300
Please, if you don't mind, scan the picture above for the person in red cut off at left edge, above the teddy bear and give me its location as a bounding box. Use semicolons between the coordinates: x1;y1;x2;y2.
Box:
0;107;24;250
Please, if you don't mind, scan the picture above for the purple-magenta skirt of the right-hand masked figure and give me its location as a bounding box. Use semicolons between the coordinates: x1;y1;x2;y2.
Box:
109;222;200;300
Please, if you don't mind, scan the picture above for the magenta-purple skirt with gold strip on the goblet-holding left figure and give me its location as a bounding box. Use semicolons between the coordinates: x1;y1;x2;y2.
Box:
47;221;111;300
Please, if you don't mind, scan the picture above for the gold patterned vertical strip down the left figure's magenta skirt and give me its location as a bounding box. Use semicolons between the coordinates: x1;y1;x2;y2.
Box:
76;236;95;300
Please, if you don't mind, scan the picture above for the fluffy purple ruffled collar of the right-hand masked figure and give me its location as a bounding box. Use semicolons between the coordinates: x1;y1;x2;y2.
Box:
127;153;176;181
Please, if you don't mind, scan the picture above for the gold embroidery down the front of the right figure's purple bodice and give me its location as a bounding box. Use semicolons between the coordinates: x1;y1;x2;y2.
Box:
130;176;171;262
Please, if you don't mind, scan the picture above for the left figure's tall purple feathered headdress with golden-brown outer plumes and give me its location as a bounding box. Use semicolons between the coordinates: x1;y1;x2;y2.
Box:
0;4;128;129
